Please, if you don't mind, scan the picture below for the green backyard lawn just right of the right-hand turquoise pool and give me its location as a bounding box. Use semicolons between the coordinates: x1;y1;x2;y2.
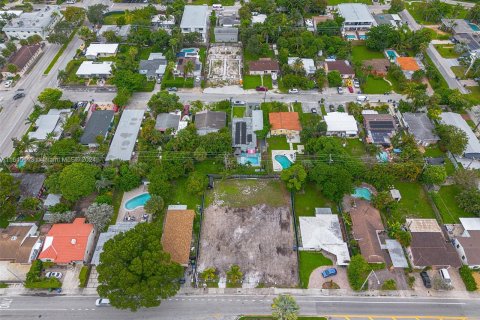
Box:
387;182;435;222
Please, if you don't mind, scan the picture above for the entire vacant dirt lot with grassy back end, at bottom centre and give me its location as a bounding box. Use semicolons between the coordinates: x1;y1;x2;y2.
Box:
198;180;298;287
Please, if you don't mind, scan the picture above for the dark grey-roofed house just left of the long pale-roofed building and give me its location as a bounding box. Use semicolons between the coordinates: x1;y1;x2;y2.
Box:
80;110;115;147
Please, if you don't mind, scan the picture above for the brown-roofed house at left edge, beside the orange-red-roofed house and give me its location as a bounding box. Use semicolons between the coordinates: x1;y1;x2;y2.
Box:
0;222;42;268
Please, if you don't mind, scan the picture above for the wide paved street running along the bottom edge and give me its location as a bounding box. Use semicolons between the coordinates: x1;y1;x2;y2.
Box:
0;295;480;320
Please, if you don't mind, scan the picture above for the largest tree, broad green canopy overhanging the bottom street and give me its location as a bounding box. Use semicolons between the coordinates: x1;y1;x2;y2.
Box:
97;223;183;311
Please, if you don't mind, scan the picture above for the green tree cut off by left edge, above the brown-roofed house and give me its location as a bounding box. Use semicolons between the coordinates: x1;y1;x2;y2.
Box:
0;172;20;219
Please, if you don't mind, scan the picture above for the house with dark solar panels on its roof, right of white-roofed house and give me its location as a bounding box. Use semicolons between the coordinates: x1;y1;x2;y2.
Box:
363;114;396;146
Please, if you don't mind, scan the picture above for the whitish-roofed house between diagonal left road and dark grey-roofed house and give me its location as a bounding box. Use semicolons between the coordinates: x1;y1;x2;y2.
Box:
28;109;71;140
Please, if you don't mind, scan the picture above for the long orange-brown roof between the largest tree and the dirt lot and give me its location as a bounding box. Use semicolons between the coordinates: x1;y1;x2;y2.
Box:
162;210;195;265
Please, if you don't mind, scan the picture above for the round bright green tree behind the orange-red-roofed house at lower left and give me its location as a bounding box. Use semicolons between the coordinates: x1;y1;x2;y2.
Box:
58;163;99;201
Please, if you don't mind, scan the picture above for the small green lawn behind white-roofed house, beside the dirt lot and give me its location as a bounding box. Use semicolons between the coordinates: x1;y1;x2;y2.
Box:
295;183;338;217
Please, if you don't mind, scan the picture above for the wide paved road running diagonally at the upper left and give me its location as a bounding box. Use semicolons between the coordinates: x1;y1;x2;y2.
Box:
0;37;82;158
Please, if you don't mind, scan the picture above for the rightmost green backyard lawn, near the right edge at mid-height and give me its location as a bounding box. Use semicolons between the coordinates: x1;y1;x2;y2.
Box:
432;185;475;223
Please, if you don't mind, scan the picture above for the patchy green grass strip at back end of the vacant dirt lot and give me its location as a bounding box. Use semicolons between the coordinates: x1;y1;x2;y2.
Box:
206;179;290;208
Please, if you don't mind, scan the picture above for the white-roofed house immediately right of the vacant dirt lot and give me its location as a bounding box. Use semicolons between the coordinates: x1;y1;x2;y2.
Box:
299;214;350;265
